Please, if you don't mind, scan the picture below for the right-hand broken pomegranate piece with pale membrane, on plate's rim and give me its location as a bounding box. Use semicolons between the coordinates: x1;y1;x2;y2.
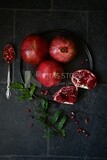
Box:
71;69;97;89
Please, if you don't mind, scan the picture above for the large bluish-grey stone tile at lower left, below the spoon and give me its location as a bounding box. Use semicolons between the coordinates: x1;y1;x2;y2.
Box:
0;84;47;156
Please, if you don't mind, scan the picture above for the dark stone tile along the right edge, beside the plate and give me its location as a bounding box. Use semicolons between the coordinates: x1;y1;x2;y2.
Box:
89;12;107;83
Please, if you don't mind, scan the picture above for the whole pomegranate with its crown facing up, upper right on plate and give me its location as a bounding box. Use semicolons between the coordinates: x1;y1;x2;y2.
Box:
49;36;77;63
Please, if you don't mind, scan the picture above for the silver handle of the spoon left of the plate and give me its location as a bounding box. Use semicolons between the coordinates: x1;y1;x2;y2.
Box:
6;64;11;99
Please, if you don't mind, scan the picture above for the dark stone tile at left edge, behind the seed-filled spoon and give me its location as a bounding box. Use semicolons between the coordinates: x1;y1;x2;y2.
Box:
0;10;13;82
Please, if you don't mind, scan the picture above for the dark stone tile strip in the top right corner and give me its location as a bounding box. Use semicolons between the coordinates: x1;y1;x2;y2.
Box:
53;0;107;11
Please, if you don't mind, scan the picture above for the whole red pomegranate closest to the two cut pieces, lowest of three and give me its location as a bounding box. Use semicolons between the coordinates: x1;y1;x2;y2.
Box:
36;60;63;87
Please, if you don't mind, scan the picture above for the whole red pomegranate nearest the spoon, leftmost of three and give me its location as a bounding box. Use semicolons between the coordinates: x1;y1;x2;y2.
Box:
20;35;48;65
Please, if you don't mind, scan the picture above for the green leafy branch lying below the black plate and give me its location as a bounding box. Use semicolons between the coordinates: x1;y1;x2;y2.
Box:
11;82;69;138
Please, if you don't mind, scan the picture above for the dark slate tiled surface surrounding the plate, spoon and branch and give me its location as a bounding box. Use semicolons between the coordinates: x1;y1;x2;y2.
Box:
0;0;107;160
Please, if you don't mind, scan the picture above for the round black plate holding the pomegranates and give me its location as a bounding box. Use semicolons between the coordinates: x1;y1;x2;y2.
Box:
20;30;93;99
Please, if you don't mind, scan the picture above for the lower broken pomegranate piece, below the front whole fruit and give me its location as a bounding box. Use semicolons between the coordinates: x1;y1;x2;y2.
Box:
53;86;78;104
